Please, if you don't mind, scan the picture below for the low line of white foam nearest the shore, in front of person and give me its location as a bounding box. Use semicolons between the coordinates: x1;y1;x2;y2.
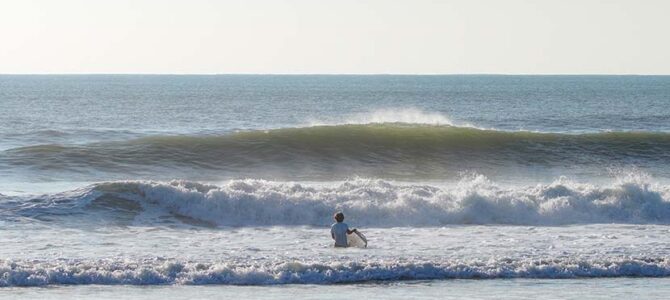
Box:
0;258;670;287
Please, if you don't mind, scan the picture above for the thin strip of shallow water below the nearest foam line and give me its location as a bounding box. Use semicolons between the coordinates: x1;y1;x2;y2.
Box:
5;278;670;300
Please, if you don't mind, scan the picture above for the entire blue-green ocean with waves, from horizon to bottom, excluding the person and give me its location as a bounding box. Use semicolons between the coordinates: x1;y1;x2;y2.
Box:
0;75;670;299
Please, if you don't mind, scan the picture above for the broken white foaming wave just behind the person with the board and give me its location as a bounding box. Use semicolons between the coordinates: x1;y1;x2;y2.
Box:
9;176;670;227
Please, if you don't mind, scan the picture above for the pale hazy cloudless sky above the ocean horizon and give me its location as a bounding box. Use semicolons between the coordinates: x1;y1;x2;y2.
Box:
0;0;670;74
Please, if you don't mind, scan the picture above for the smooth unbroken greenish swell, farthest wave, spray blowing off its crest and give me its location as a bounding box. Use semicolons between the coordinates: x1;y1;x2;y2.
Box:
0;123;670;180
